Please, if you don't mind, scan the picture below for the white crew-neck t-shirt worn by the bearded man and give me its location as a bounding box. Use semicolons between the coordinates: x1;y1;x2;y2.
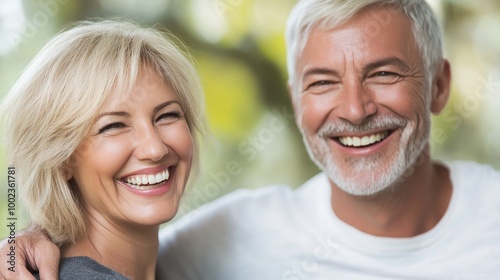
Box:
157;162;500;280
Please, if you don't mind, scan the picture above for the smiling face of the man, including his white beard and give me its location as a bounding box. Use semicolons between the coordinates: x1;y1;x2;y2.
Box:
292;8;432;195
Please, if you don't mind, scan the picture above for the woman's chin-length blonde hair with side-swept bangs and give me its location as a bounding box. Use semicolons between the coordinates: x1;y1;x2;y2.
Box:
1;21;207;244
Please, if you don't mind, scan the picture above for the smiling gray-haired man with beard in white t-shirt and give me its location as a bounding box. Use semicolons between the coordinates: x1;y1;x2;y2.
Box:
2;0;500;279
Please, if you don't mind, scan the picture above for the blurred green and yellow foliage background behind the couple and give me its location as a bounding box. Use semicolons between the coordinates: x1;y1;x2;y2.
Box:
0;0;500;238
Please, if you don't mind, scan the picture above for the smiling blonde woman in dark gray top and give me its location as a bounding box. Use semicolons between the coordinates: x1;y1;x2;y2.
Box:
2;21;205;279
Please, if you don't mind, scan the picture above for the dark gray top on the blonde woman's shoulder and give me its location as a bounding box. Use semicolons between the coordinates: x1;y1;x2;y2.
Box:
33;257;128;280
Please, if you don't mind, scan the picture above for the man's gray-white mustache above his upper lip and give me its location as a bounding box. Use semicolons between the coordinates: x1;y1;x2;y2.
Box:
318;116;408;138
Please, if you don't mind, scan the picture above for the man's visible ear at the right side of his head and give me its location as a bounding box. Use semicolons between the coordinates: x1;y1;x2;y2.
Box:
431;59;451;115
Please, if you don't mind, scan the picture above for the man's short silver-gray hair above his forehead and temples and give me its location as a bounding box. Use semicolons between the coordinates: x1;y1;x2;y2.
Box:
286;0;443;85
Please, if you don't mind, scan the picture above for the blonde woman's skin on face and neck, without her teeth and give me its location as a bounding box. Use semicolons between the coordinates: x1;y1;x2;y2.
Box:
61;68;193;279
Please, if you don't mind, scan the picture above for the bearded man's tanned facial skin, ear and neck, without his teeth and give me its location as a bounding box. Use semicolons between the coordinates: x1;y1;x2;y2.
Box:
291;8;451;237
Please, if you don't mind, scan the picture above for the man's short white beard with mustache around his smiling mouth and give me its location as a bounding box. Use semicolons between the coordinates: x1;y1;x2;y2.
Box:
302;113;430;196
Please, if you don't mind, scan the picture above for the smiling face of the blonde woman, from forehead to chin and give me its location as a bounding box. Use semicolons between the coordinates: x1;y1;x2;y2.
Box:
67;67;193;230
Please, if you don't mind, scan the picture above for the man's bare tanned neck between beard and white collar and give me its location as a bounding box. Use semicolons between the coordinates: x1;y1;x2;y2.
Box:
330;158;451;237
